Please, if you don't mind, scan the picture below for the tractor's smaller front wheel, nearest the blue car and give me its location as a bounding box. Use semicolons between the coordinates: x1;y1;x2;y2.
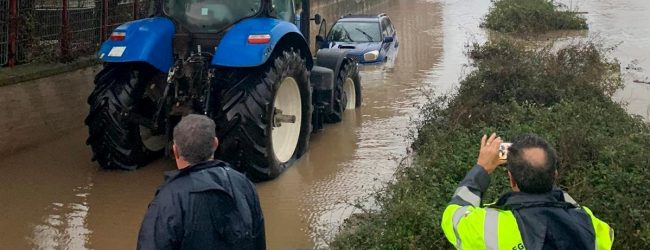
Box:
325;62;361;123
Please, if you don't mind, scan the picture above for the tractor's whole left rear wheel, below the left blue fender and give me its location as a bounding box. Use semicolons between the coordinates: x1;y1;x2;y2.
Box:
85;64;167;170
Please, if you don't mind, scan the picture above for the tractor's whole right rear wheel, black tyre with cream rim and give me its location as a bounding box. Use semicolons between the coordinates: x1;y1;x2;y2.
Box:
214;52;313;181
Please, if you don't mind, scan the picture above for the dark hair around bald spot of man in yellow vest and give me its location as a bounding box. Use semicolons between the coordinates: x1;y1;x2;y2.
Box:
508;134;557;194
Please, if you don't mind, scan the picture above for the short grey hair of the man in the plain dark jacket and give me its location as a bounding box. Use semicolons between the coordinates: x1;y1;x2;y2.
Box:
174;115;216;164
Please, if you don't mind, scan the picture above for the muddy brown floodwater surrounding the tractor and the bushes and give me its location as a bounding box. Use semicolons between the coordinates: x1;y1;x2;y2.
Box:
0;0;650;249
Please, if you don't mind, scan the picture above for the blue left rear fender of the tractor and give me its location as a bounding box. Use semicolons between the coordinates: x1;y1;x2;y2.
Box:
98;17;176;72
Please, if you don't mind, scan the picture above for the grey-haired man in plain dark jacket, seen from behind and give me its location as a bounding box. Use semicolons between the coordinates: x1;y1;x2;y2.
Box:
138;115;266;249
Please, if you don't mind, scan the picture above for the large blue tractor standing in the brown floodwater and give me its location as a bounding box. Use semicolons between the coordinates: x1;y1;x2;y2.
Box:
85;0;361;180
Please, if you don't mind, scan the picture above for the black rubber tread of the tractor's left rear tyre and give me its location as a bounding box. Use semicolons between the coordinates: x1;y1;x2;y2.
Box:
85;64;155;170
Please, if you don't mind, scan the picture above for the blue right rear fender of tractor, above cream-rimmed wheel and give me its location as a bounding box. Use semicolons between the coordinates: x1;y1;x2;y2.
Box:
211;17;313;69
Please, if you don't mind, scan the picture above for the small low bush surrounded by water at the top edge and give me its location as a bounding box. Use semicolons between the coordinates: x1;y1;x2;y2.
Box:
483;0;587;33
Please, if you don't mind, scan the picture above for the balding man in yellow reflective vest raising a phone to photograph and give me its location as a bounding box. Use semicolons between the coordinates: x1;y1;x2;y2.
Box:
442;134;614;250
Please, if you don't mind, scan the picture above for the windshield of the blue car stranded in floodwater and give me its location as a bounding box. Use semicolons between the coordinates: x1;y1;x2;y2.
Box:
329;21;381;42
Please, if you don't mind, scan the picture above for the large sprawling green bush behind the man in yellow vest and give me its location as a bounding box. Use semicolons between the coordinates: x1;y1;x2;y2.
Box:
331;40;650;249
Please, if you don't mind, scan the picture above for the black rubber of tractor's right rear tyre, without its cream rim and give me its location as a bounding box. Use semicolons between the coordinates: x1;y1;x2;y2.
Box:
213;51;313;181
